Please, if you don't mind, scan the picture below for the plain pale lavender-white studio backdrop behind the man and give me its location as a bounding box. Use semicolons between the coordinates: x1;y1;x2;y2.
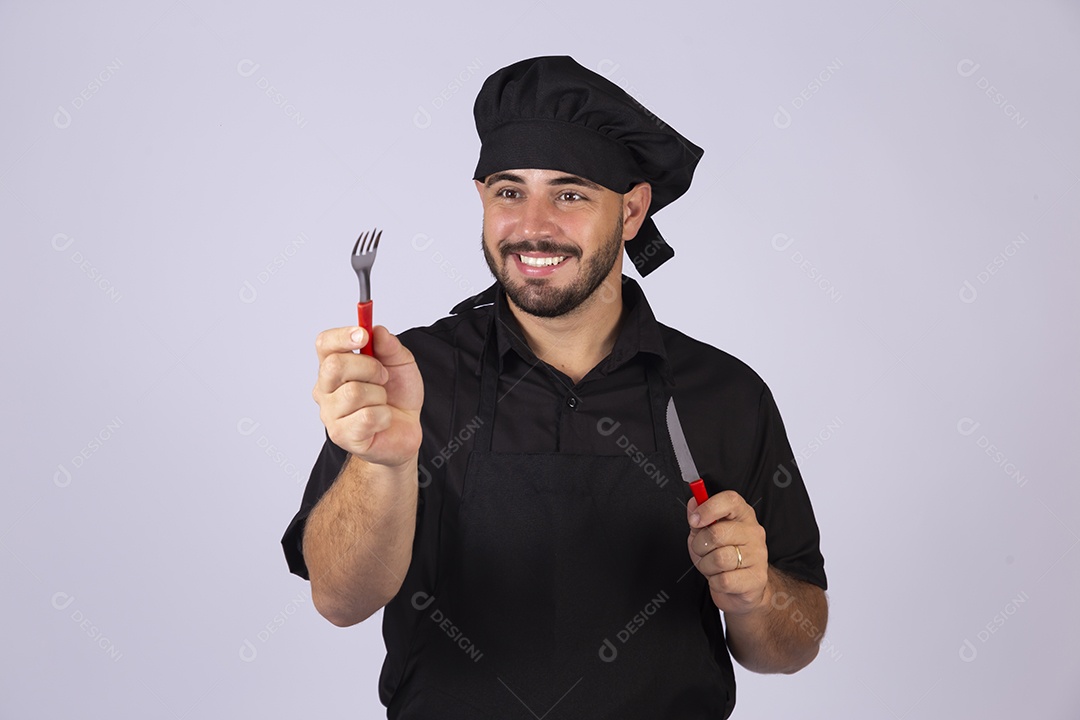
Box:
0;0;1080;719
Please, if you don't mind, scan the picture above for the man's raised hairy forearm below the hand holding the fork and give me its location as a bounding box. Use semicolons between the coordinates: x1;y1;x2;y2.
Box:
303;456;418;627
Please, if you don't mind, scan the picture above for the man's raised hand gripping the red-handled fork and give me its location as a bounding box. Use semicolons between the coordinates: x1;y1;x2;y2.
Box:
311;325;423;467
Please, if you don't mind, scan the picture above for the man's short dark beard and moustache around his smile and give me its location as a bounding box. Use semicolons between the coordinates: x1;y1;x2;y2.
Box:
481;213;622;317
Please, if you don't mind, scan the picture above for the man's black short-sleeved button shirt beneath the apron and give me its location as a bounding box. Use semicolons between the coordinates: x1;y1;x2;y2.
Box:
282;277;826;705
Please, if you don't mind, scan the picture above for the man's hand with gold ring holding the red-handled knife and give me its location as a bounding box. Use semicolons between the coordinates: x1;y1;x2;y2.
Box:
687;490;769;614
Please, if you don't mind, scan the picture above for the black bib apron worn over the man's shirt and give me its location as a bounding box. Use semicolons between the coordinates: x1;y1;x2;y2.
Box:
390;332;734;720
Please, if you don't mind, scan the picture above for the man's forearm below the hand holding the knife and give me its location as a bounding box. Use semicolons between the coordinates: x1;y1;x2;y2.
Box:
724;566;828;674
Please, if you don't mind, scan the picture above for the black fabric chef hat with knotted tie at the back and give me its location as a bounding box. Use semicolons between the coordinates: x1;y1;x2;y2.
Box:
473;56;704;276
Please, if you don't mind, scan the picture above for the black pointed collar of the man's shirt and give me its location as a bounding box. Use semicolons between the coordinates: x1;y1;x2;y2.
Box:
455;275;672;383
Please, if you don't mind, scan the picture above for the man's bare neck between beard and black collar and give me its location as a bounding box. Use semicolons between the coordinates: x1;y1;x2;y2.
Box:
507;275;623;384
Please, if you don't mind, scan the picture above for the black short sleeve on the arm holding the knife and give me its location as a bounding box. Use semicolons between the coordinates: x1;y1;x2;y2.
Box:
745;386;827;589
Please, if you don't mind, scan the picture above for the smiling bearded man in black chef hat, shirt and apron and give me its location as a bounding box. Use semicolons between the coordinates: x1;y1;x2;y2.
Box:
282;57;826;719
